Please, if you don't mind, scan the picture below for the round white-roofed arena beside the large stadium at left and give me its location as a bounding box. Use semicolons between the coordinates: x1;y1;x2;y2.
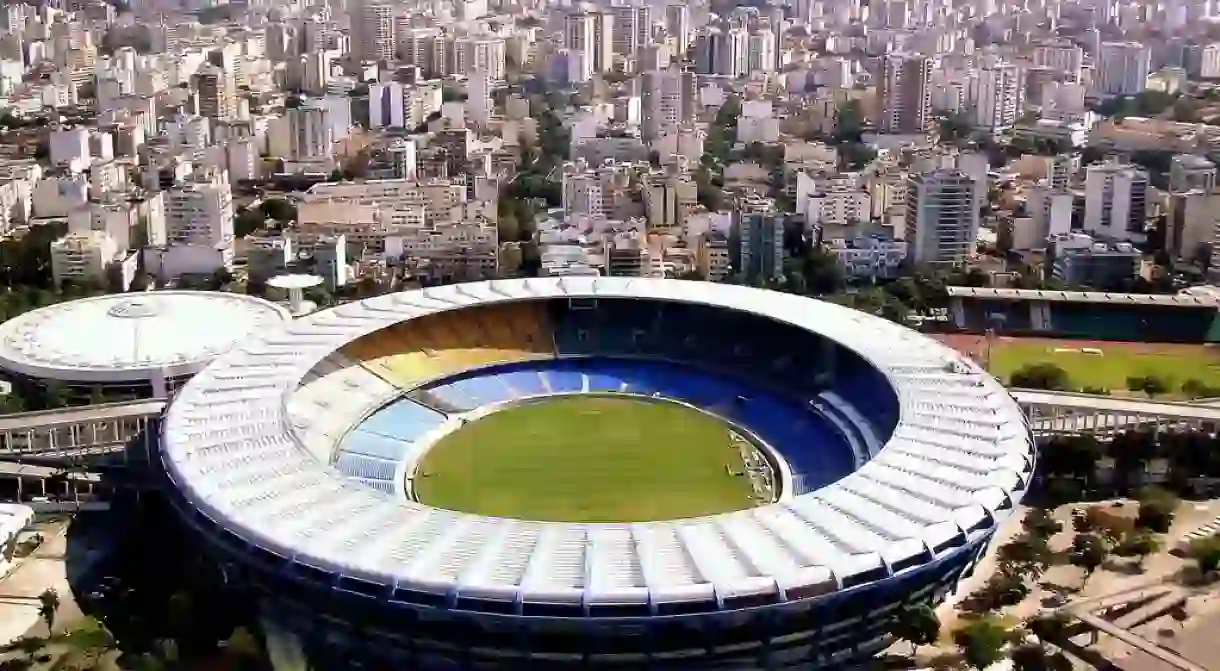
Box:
0;292;290;397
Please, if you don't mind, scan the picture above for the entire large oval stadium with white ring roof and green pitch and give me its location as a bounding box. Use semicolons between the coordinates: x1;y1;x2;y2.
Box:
160;277;1035;669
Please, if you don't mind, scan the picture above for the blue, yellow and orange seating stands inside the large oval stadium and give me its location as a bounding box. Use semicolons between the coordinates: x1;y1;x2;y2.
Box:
324;300;907;493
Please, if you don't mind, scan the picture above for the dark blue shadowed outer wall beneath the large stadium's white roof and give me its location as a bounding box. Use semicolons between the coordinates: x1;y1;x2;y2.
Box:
154;280;1032;669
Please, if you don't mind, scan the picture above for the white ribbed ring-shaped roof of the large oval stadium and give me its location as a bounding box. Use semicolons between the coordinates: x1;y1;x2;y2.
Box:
162;277;1033;608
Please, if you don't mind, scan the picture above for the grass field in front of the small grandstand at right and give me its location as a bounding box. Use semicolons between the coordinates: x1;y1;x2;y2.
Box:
991;338;1220;397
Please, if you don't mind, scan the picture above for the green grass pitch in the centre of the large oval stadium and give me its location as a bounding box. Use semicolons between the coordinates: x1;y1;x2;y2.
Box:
415;397;754;522
